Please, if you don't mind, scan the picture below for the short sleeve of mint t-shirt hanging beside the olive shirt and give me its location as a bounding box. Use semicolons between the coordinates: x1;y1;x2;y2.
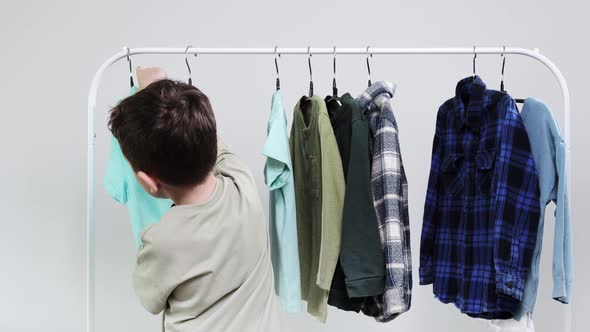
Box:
263;119;291;190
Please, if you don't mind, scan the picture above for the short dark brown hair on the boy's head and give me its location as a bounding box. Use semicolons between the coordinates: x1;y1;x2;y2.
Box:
109;79;217;186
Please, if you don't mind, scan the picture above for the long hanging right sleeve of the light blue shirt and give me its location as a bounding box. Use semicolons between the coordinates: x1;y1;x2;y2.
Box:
553;141;574;303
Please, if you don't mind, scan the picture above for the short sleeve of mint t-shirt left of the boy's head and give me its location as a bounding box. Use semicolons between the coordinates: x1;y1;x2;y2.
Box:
104;136;129;205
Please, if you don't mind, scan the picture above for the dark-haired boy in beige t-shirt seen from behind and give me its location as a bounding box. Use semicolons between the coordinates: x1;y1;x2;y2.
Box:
109;79;280;332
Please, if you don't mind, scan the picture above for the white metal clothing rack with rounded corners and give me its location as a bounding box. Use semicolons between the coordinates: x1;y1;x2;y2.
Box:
86;47;571;332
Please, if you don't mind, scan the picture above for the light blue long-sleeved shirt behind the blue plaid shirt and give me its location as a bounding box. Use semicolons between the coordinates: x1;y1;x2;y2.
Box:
515;98;574;319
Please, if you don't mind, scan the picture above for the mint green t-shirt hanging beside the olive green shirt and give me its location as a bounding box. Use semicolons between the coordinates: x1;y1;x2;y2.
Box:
263;91;301;312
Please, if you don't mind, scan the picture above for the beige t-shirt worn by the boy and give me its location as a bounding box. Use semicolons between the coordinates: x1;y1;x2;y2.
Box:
133;144;281;332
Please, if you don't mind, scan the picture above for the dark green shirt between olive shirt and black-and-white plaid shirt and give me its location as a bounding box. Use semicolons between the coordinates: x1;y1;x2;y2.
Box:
326;93;385;313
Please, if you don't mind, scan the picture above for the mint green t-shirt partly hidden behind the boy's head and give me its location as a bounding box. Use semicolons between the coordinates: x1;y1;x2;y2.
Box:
104;89;172;247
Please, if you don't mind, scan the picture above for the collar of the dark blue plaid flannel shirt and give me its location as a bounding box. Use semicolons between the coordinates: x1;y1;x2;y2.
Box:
455;75;486;132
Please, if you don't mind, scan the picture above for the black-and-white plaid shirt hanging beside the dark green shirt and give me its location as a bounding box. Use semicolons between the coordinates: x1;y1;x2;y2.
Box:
356;82;412;321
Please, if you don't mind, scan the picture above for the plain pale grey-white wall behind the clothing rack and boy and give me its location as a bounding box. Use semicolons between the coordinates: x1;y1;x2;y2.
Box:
0;0;590;332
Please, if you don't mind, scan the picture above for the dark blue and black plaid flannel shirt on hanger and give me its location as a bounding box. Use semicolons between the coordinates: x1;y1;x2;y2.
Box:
419;76;540;319
